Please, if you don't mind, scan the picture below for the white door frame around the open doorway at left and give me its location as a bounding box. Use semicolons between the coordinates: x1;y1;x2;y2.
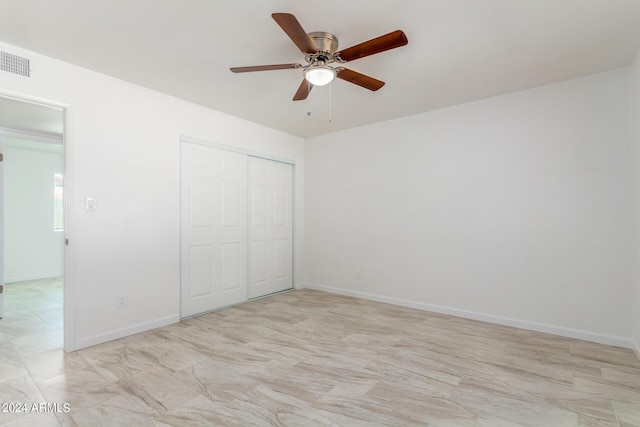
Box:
0;88;76;352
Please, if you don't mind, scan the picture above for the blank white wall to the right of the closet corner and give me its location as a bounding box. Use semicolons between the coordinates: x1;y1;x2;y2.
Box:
305;68;634;346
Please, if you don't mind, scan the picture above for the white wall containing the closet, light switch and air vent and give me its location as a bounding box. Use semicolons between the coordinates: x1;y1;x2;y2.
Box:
0;43;304;350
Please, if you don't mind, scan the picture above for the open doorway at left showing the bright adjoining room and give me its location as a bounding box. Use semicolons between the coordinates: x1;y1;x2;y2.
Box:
0;96;65;357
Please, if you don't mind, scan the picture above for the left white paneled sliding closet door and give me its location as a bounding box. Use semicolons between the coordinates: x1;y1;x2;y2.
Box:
180;142;247;317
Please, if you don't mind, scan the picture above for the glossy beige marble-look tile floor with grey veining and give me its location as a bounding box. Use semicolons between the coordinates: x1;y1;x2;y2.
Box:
0;281;640;427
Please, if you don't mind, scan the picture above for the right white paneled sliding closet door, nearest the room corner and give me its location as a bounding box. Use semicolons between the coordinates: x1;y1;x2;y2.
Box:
247;157;293;298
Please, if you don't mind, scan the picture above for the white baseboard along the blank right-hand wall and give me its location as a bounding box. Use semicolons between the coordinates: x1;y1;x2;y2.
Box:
296;283;640;350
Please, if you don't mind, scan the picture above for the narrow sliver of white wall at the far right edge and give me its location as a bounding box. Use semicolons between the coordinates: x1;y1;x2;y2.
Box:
632;51;640;357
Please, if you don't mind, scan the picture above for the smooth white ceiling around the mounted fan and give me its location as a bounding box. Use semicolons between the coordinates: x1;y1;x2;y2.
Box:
0;0;640;138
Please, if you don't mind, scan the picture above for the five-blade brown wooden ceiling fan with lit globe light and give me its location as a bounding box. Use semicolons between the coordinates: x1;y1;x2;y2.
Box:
230;13;408;101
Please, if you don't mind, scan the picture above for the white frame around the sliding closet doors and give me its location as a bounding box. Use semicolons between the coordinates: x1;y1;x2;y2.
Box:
177;134;296;319
